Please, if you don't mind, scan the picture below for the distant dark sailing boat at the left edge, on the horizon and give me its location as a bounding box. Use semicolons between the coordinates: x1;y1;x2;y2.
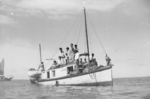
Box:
0;59;13;81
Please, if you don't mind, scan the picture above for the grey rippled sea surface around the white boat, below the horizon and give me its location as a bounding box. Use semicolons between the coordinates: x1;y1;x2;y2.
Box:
0;77;150;99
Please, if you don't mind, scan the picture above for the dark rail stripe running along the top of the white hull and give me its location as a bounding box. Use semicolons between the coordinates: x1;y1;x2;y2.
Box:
37;66;112;82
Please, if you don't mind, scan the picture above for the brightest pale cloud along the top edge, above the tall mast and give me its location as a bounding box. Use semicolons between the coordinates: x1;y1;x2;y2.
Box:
18;0;124;11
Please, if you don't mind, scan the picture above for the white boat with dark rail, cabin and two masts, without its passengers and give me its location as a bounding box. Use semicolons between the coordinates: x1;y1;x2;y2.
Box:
28;7;113;86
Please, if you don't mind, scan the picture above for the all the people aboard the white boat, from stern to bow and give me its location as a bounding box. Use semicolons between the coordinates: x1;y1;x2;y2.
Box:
38;43;111;71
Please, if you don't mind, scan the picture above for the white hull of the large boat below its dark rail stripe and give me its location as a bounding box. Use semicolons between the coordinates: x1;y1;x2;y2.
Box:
30;68;113;86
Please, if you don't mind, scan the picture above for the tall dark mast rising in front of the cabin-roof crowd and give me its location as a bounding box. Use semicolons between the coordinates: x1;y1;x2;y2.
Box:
84;7;90;62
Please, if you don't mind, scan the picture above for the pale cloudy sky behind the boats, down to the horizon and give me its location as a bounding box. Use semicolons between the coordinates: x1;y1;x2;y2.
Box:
0;0;150;79
